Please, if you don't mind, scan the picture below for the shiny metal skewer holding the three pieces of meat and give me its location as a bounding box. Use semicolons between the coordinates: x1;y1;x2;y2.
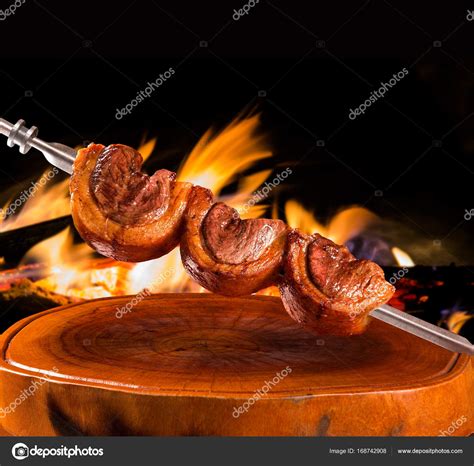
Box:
0;118;474;356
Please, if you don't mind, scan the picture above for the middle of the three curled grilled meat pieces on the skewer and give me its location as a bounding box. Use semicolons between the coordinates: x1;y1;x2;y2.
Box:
180;186;287;296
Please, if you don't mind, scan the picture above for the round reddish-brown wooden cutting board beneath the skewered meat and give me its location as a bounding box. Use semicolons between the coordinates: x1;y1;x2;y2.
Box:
0;294;474;436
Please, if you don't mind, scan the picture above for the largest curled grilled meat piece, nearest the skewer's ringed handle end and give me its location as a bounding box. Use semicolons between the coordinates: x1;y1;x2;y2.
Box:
70;144;192;262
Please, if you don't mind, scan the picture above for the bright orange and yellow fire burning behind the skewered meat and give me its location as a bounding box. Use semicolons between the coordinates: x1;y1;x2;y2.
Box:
0;115;420;299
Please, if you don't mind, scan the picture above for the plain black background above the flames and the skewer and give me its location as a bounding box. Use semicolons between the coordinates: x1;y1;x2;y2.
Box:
0;0;474;265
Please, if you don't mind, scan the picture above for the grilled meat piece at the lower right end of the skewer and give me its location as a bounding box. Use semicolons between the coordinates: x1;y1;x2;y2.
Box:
280;230;395;335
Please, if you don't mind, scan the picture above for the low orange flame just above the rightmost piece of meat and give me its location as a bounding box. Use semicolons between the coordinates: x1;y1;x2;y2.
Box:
285;200;378;244
